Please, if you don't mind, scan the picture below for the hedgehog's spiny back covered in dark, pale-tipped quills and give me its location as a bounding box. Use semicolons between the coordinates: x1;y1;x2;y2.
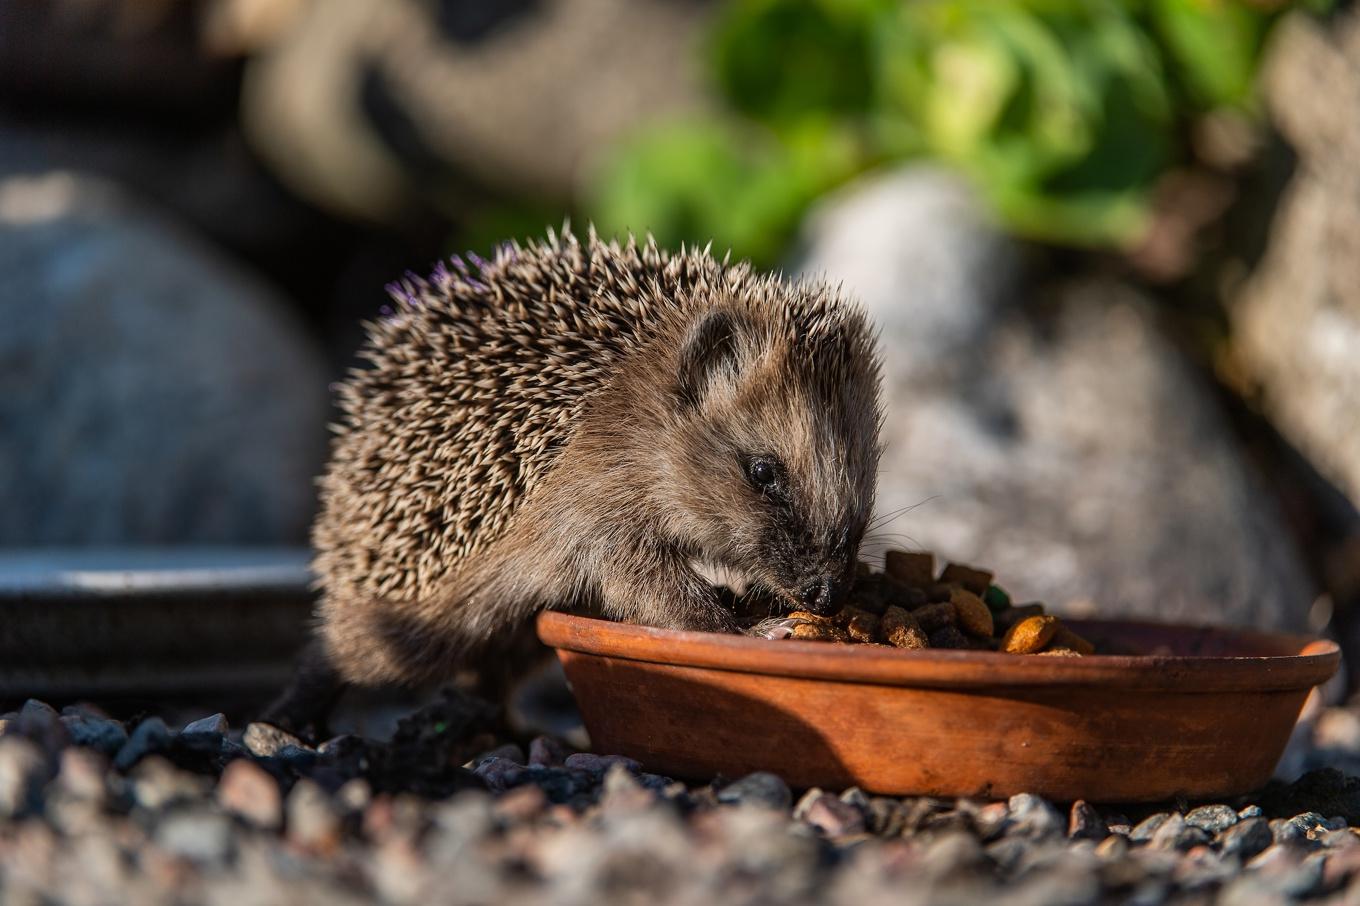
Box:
313;233;718;600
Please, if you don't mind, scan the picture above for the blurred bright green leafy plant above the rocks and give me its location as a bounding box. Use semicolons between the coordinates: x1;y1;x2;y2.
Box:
592;0;1305;264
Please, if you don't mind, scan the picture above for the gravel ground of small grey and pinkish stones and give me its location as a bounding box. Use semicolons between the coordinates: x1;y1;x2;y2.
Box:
0;692;1360;906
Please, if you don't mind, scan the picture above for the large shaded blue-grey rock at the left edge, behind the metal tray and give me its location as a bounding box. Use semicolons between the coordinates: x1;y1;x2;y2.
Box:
0;173;328;546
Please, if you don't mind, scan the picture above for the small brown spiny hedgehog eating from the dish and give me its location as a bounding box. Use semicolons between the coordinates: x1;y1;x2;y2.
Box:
267;227;881;724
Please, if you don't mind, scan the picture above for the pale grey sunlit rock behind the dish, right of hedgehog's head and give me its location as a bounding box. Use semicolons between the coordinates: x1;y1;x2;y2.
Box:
806;165;1312;626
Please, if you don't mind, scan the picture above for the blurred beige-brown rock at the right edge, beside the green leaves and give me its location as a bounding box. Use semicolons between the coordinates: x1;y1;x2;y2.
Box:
1232;12;1360;506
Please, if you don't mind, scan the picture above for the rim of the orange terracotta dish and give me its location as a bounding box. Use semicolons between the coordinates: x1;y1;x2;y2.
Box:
537;611;1341;694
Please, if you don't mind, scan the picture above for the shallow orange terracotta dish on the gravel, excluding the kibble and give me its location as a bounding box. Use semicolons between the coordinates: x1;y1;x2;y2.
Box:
539;612;1341;803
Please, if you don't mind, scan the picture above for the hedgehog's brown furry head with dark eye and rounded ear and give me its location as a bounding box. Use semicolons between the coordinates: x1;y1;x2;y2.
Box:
661;304;879;612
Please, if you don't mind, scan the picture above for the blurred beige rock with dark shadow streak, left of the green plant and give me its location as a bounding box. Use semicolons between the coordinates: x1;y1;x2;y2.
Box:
242;0;711;222
